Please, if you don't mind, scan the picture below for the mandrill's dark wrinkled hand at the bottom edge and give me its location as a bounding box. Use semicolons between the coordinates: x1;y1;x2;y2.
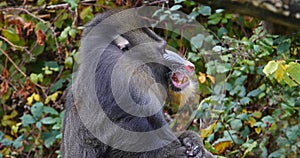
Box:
178;131;215;158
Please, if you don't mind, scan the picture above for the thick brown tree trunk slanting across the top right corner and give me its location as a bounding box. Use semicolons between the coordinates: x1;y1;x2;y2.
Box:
195;0;300;34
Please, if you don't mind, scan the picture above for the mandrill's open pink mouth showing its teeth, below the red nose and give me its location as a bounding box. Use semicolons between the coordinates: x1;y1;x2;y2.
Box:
171;72;190;89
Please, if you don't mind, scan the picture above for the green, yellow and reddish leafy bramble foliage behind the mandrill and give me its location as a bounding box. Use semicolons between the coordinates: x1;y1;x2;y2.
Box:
0;0;300;157
